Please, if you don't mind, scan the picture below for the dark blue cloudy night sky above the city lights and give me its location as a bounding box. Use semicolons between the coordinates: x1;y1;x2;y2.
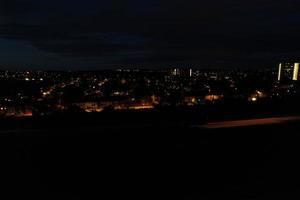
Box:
0;0;300;69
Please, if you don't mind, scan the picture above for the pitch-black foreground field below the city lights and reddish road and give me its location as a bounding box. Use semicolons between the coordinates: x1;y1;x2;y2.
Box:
0;118;300;200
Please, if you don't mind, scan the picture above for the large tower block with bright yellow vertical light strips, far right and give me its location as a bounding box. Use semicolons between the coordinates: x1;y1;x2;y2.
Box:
277;63;299;81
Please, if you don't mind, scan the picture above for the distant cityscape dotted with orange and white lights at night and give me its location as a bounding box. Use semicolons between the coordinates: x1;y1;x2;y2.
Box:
0;63;300;117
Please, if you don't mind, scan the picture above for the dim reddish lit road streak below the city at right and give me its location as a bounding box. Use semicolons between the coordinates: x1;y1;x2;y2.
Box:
200;116;300;129
